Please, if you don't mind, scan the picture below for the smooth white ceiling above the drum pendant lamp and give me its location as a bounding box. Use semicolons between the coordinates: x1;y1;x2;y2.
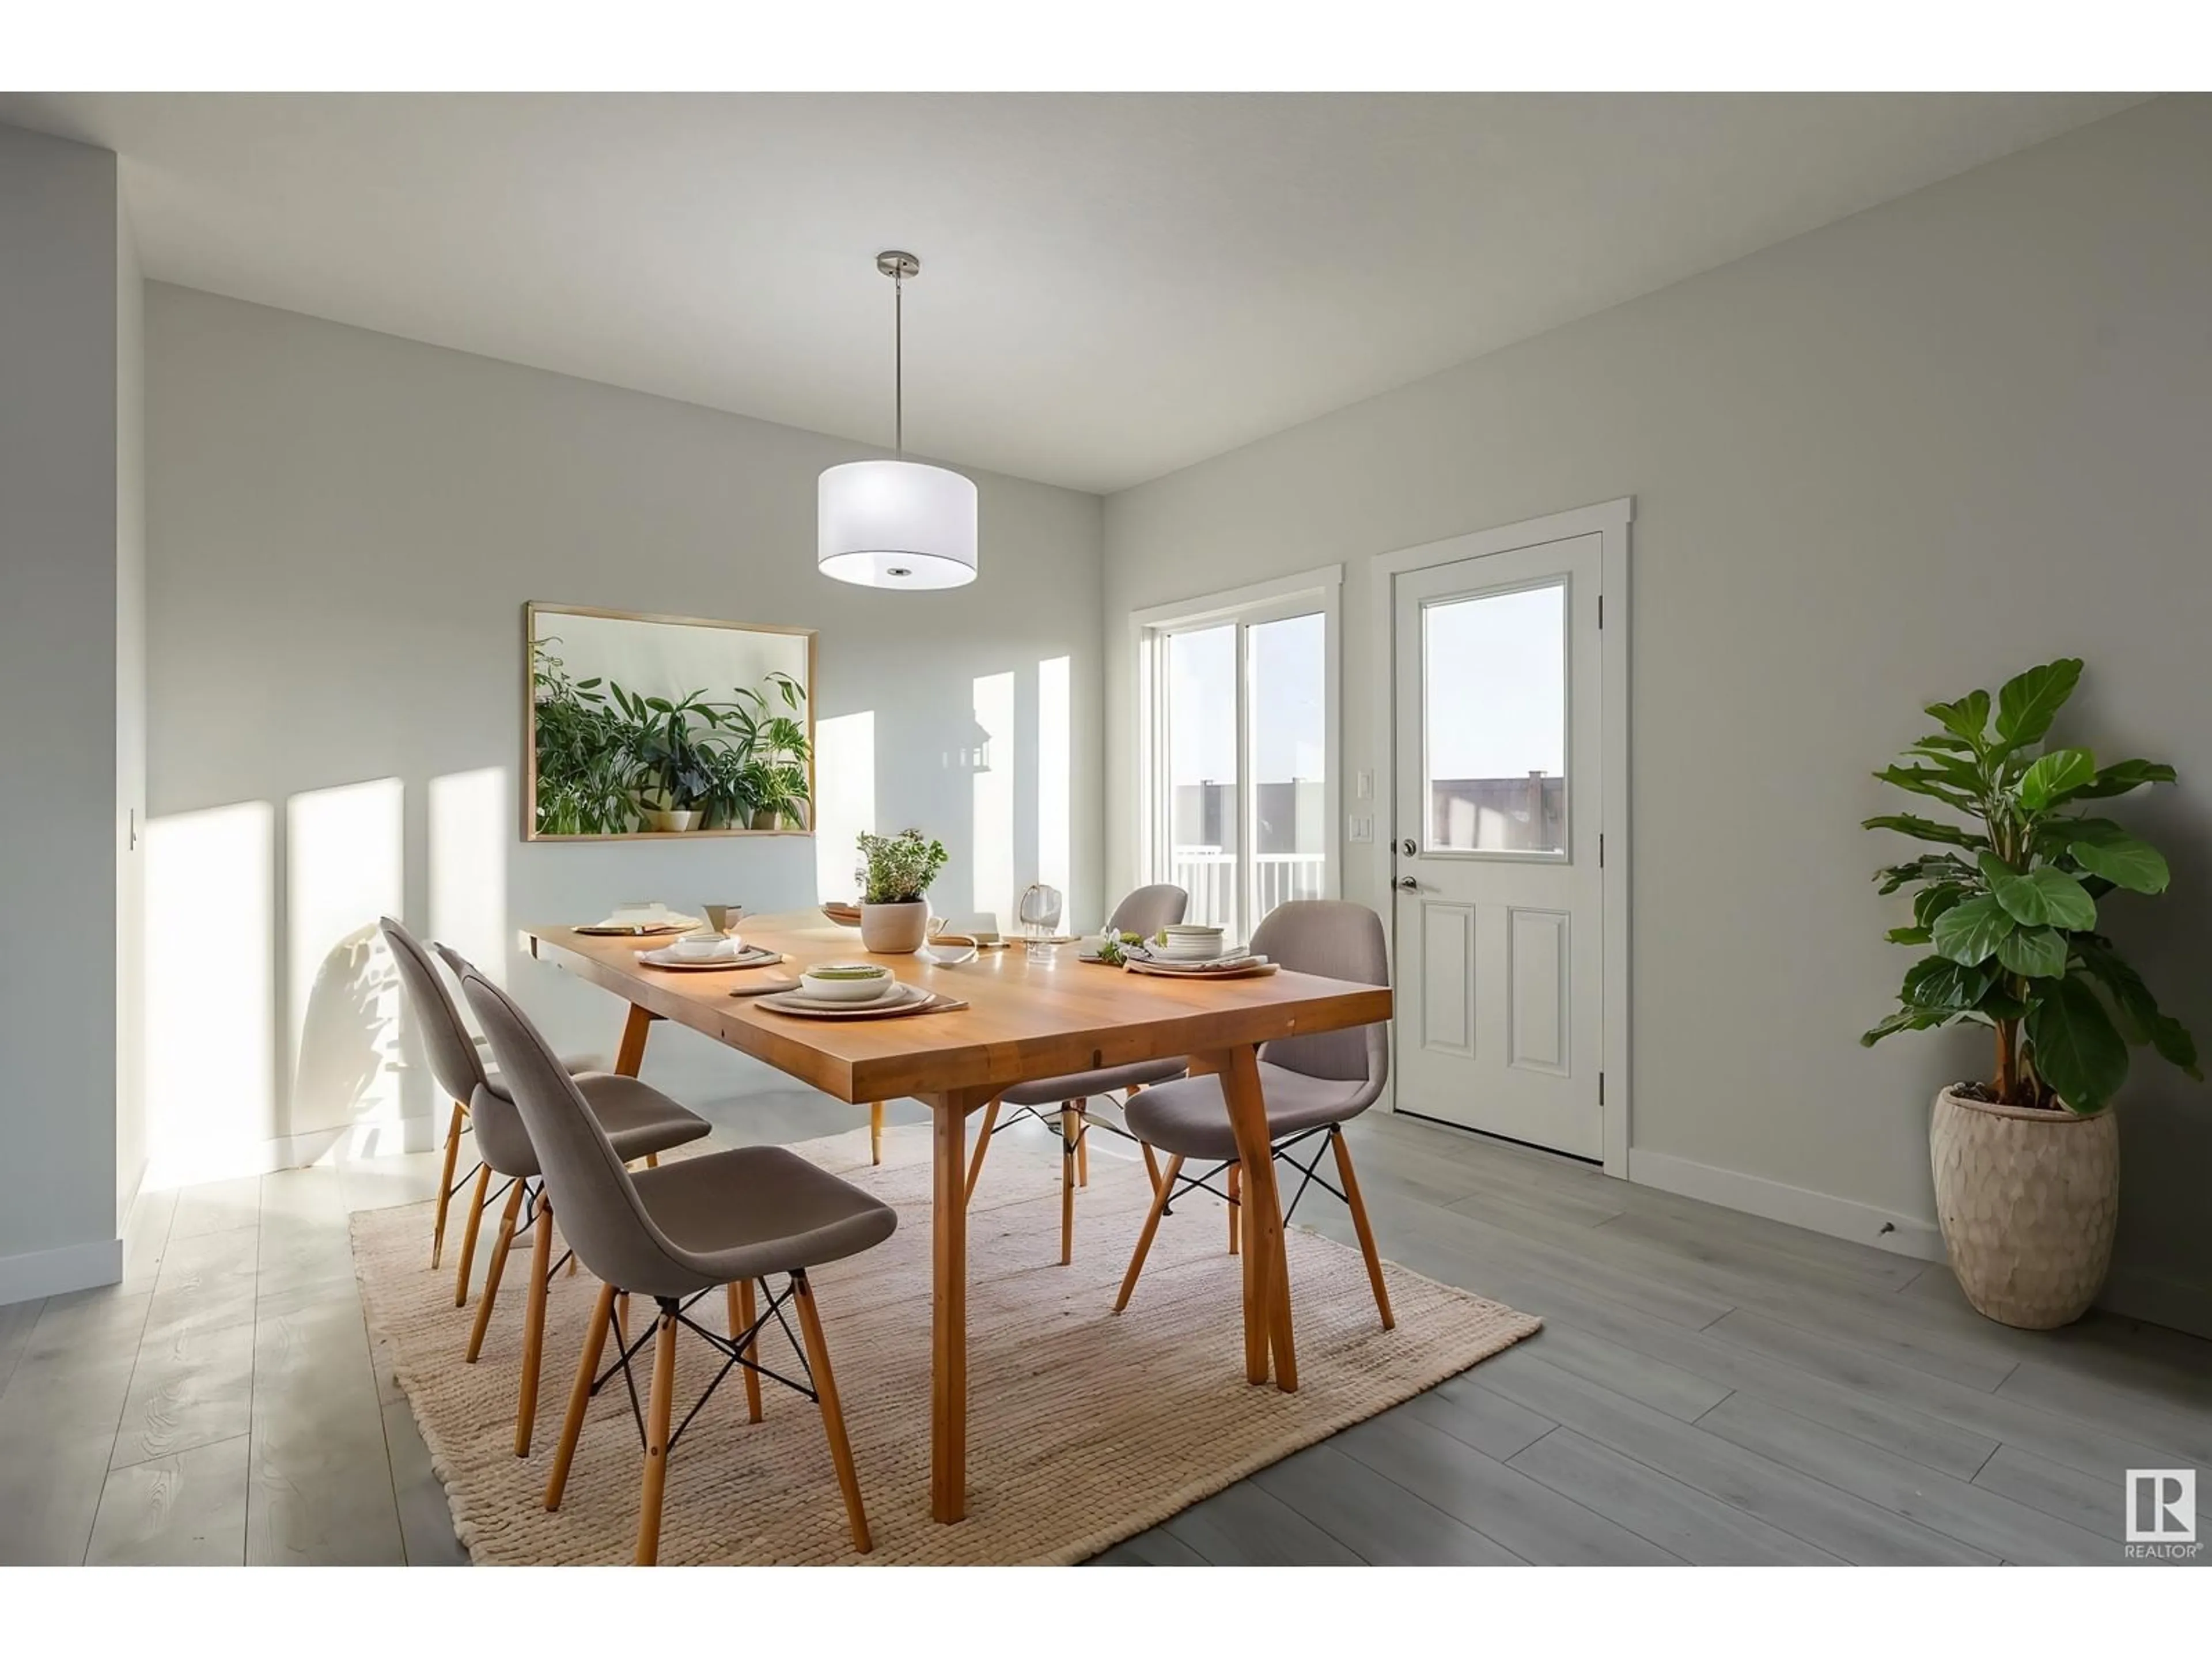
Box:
0;93;2139;491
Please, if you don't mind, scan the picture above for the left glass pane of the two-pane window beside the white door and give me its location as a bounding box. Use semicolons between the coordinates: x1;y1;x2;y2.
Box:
1166;622;1241;931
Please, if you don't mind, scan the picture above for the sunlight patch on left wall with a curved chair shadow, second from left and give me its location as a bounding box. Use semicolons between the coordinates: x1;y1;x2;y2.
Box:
281;779;407;1135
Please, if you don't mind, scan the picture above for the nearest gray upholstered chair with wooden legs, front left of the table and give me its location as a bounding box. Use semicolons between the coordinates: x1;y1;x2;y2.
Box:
460;969;898;1566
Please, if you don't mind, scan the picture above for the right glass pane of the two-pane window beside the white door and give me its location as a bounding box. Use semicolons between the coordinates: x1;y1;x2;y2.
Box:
1245;611;1330;927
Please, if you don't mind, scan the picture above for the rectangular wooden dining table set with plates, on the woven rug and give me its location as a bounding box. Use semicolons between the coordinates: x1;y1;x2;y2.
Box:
524;911;1391;1522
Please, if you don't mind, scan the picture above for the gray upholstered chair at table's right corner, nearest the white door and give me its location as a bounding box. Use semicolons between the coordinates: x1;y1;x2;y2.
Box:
1113;898;1396;1330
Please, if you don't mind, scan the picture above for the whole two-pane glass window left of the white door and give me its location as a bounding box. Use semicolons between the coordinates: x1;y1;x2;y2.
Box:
1146;588;1336;940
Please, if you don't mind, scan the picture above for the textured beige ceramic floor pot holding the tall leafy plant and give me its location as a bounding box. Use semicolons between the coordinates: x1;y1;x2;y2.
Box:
1929;1088;2119;1332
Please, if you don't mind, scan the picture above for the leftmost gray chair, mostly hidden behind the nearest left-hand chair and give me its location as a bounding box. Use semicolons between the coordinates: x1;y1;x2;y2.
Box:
378;916;712;1458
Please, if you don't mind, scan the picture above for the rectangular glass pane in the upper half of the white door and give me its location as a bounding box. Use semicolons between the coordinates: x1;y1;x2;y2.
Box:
1420;582;1566;854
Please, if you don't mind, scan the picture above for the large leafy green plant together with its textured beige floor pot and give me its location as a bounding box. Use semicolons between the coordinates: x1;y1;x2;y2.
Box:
1860;657;2203;1330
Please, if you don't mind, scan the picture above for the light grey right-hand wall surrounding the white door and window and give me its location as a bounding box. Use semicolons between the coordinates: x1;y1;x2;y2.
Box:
1104;97;2212;1330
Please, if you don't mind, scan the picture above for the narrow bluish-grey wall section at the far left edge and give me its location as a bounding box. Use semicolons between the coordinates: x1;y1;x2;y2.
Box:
0;128;124;1303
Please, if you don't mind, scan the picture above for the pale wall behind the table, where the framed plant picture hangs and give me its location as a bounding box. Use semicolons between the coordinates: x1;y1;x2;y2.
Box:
146;283;1101;1172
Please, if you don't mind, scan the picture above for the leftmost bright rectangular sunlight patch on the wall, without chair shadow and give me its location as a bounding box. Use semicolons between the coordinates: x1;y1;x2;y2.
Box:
146;801;279;1185
